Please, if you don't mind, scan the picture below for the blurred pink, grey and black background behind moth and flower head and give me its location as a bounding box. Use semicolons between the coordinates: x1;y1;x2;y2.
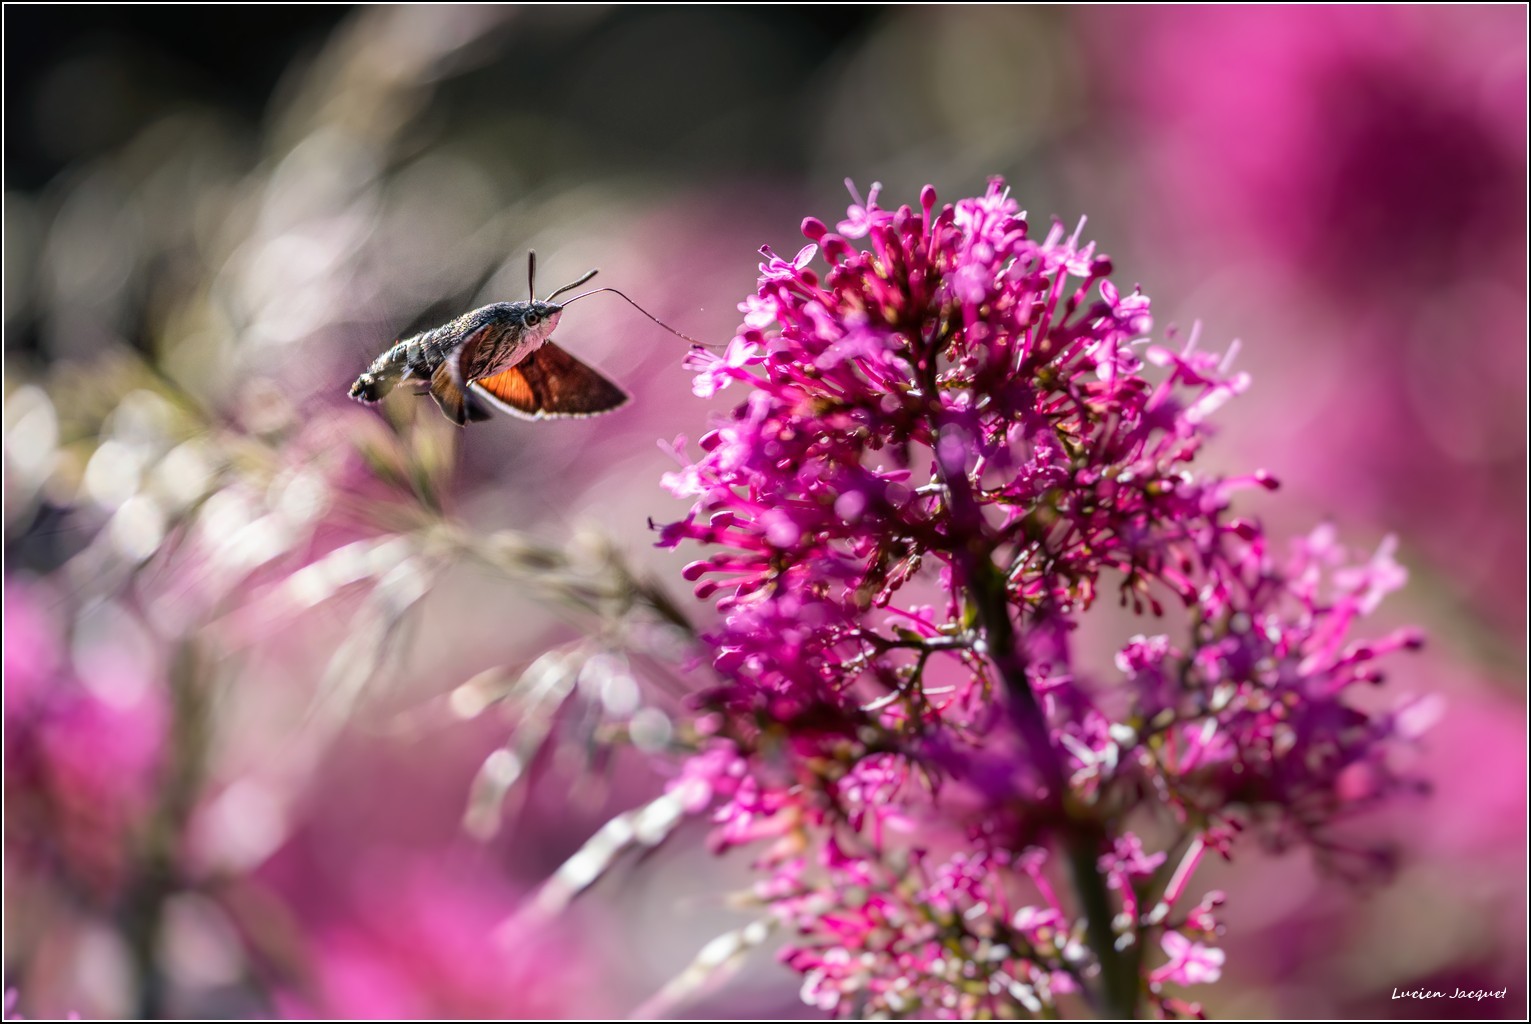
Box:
5;5;1526;1018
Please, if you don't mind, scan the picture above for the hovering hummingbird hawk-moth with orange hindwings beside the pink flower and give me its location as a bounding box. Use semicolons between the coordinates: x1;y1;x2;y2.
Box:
351;253;631;427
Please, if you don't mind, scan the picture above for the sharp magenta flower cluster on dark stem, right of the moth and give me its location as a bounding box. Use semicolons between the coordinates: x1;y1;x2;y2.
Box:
660;181;1422;1018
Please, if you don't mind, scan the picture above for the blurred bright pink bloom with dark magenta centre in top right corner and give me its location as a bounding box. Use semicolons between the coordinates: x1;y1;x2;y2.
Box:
1087;6;1526;287
